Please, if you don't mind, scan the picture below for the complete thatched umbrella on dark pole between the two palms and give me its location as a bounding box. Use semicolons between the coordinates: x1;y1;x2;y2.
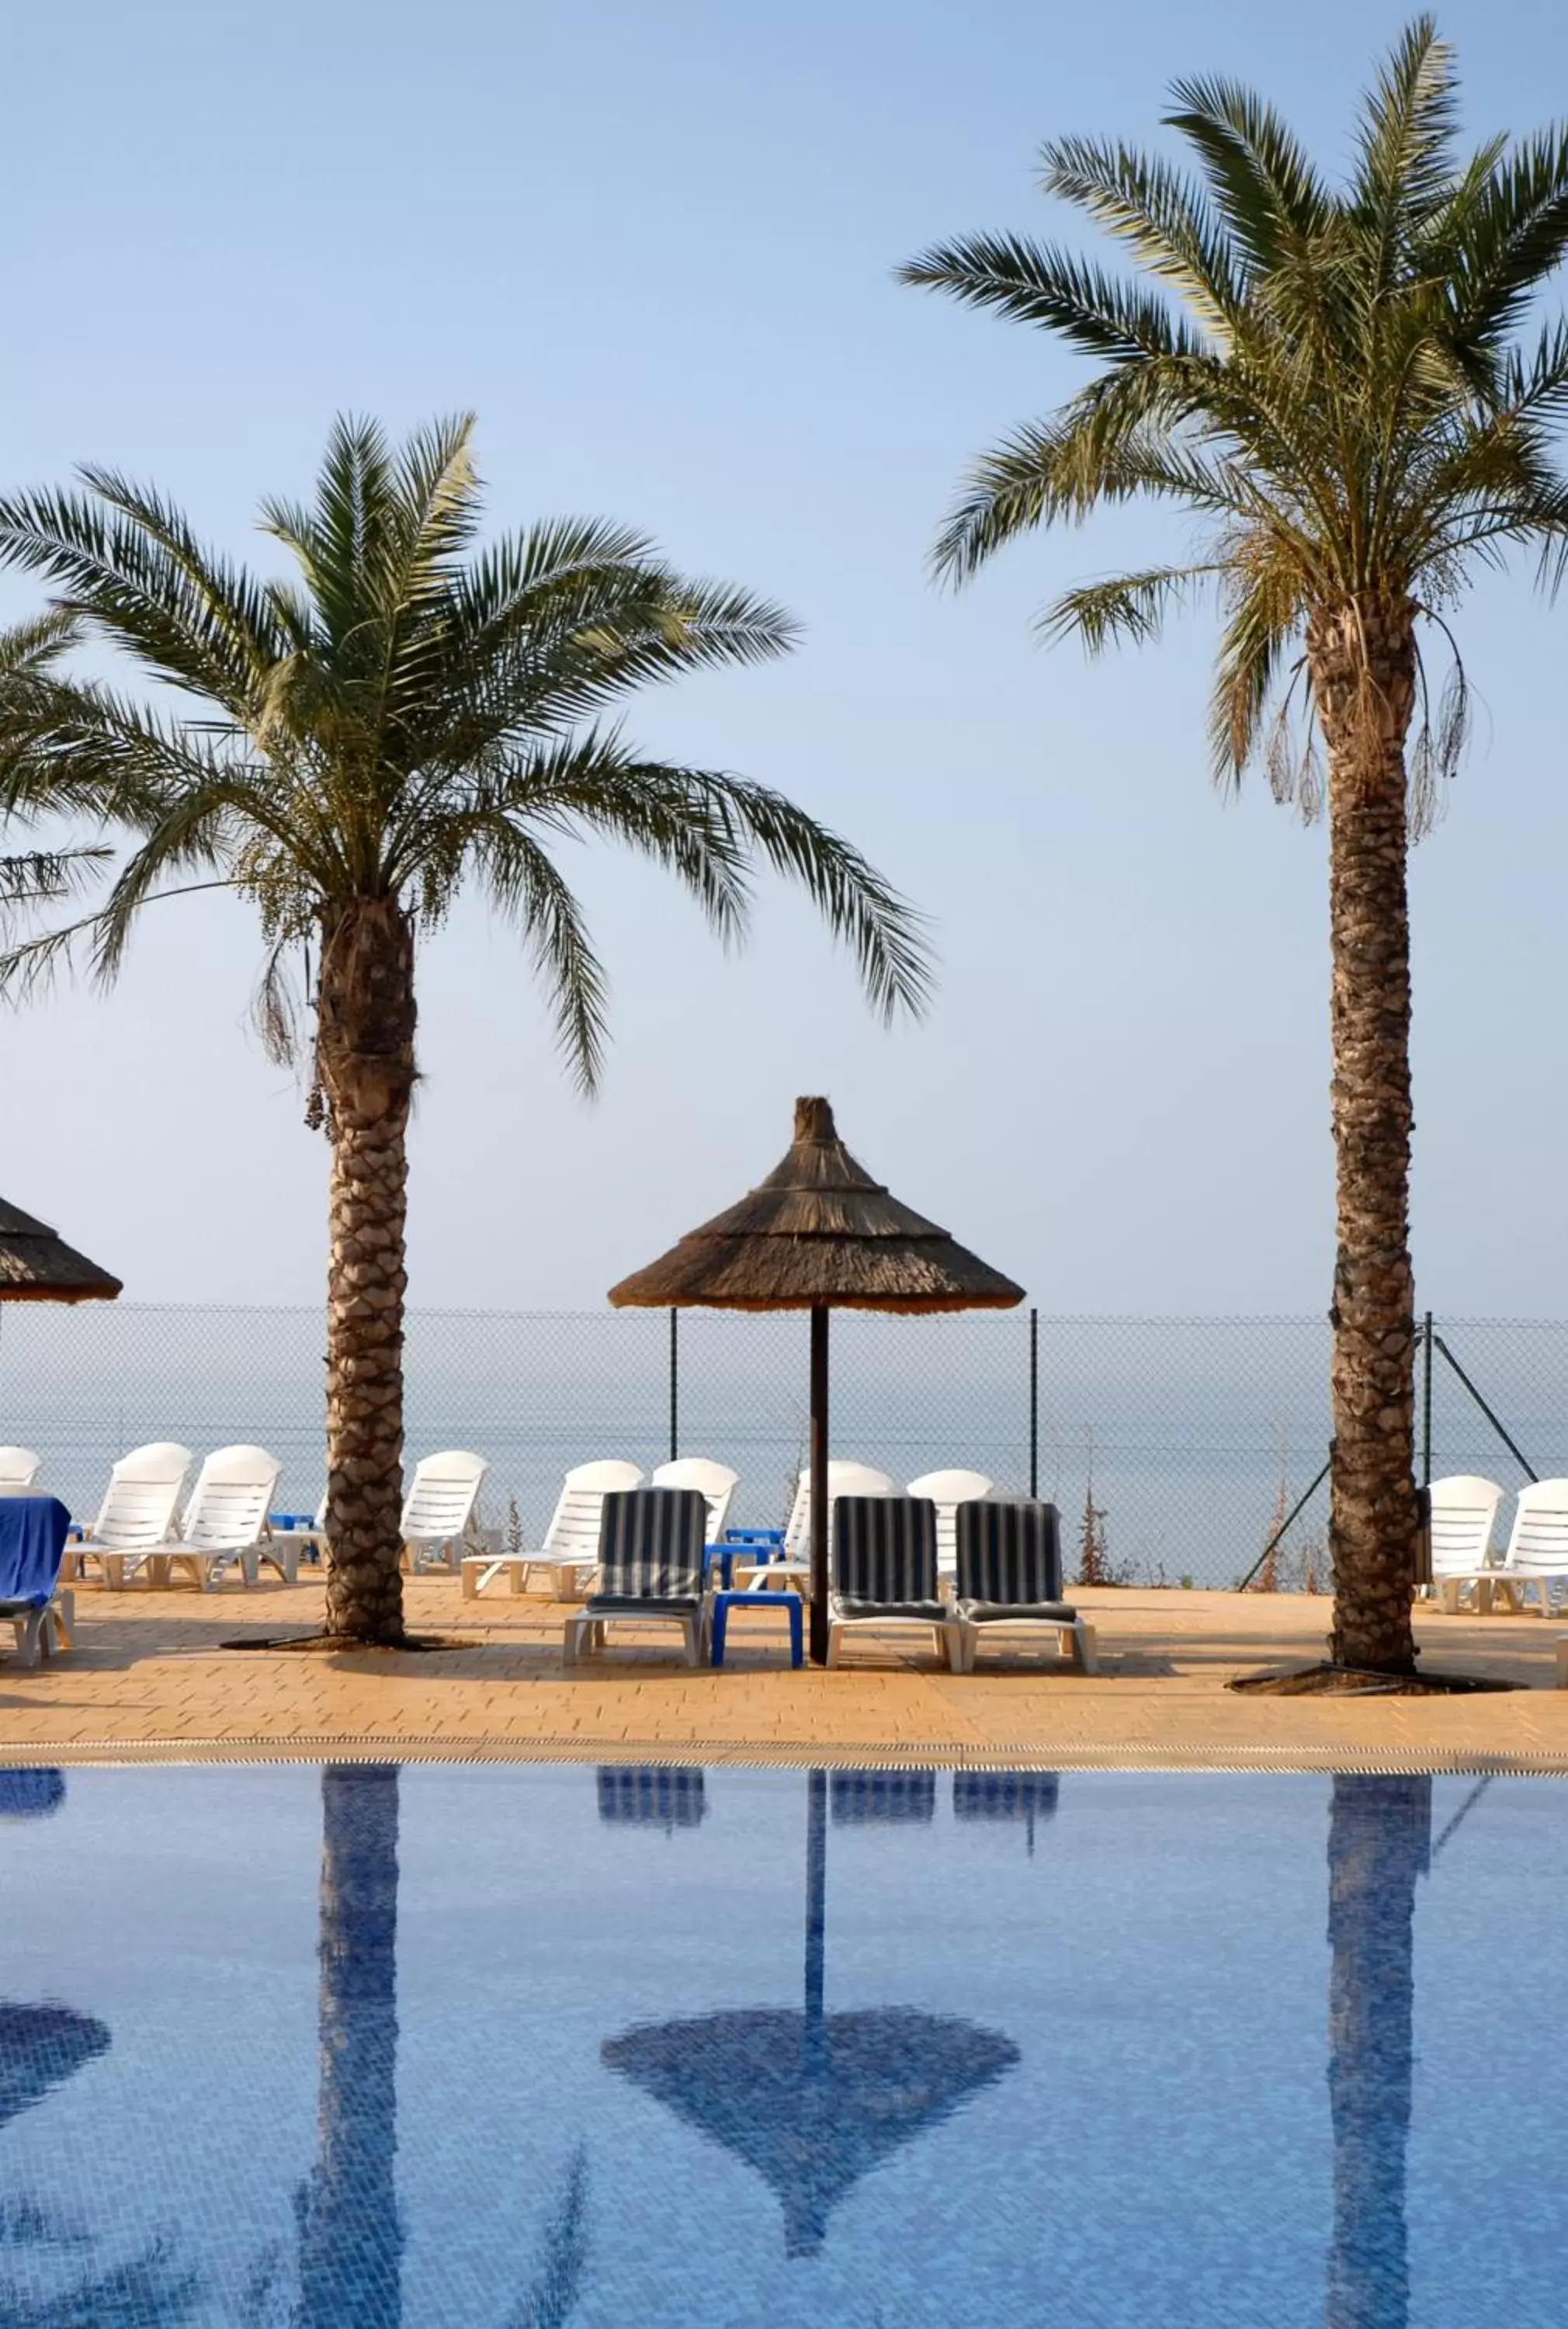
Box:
610;1099;1023;1665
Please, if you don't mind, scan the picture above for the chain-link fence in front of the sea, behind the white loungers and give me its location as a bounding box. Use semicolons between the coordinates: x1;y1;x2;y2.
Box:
0;1304;1568;1588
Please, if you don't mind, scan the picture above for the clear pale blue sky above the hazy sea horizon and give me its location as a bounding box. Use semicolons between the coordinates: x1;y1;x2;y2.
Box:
0;0;1568;1316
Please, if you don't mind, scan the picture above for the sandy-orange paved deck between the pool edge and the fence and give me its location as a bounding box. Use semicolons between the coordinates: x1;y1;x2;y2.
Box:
0;1577;1568;1775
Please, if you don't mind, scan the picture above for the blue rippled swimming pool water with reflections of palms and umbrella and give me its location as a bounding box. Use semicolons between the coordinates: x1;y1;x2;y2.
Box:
0;1765;1568;2329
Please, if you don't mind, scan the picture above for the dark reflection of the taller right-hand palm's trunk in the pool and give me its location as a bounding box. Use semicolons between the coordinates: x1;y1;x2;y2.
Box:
1323;1775;1433;2329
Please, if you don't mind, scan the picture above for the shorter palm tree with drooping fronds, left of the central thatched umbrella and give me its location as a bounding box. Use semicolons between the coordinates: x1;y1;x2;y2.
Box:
0;419;928;1644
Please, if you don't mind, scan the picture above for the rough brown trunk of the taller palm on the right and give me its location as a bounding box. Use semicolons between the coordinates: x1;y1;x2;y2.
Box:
1307;599;1419;1675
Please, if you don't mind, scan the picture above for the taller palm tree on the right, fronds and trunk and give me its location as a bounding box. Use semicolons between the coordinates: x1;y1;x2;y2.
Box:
902;19;1568;1672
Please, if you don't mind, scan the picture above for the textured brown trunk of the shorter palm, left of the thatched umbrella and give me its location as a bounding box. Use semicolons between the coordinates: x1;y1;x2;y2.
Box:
317;897;415;1644
